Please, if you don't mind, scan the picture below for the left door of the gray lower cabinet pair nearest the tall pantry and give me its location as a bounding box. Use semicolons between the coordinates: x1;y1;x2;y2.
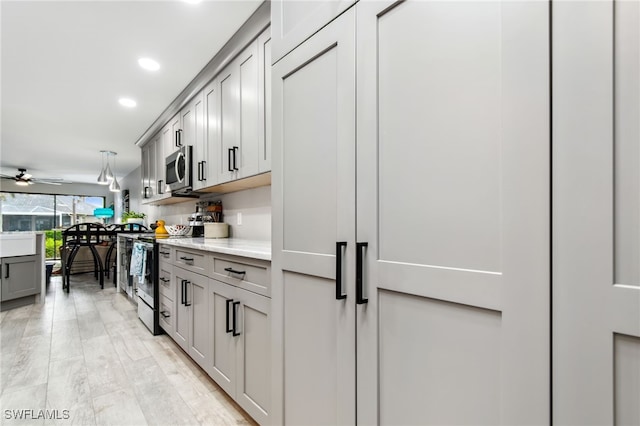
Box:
207;279;238;397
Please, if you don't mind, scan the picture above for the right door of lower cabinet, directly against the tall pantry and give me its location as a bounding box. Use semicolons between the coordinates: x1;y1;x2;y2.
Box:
235;289;271;425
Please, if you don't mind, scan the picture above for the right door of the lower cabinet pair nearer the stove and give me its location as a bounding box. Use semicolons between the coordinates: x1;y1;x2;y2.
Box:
185;273;211;368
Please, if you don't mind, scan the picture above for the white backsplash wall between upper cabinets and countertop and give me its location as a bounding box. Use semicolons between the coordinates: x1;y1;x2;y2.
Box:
120;168;271;241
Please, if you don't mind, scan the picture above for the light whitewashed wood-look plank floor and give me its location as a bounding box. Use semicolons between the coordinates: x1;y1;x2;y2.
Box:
0;274;255;425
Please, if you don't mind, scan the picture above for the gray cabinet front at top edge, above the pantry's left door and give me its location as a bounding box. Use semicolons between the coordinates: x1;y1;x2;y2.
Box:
271;0;356;62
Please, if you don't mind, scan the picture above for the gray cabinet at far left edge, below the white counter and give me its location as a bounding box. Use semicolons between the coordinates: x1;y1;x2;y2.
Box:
1;255;40;302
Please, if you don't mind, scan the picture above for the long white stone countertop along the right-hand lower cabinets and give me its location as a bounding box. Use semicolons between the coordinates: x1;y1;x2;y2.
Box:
156;238;271;261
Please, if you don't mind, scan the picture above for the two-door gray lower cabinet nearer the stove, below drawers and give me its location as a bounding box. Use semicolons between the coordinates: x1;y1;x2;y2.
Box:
173;265;211;369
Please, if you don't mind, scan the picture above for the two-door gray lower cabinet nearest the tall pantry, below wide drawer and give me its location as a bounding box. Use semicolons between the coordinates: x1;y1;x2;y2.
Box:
207;279;271;424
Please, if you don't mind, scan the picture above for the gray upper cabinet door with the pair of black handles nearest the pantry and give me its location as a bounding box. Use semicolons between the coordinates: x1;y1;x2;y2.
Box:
217;62;240;183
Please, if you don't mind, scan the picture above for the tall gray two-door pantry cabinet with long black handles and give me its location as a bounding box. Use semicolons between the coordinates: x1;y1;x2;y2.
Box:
271;1;550;424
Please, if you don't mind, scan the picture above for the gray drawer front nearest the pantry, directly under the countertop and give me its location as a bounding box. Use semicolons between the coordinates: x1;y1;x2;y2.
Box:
212;255;271;297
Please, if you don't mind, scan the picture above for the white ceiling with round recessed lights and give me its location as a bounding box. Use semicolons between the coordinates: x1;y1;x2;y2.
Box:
0;0;262;188
